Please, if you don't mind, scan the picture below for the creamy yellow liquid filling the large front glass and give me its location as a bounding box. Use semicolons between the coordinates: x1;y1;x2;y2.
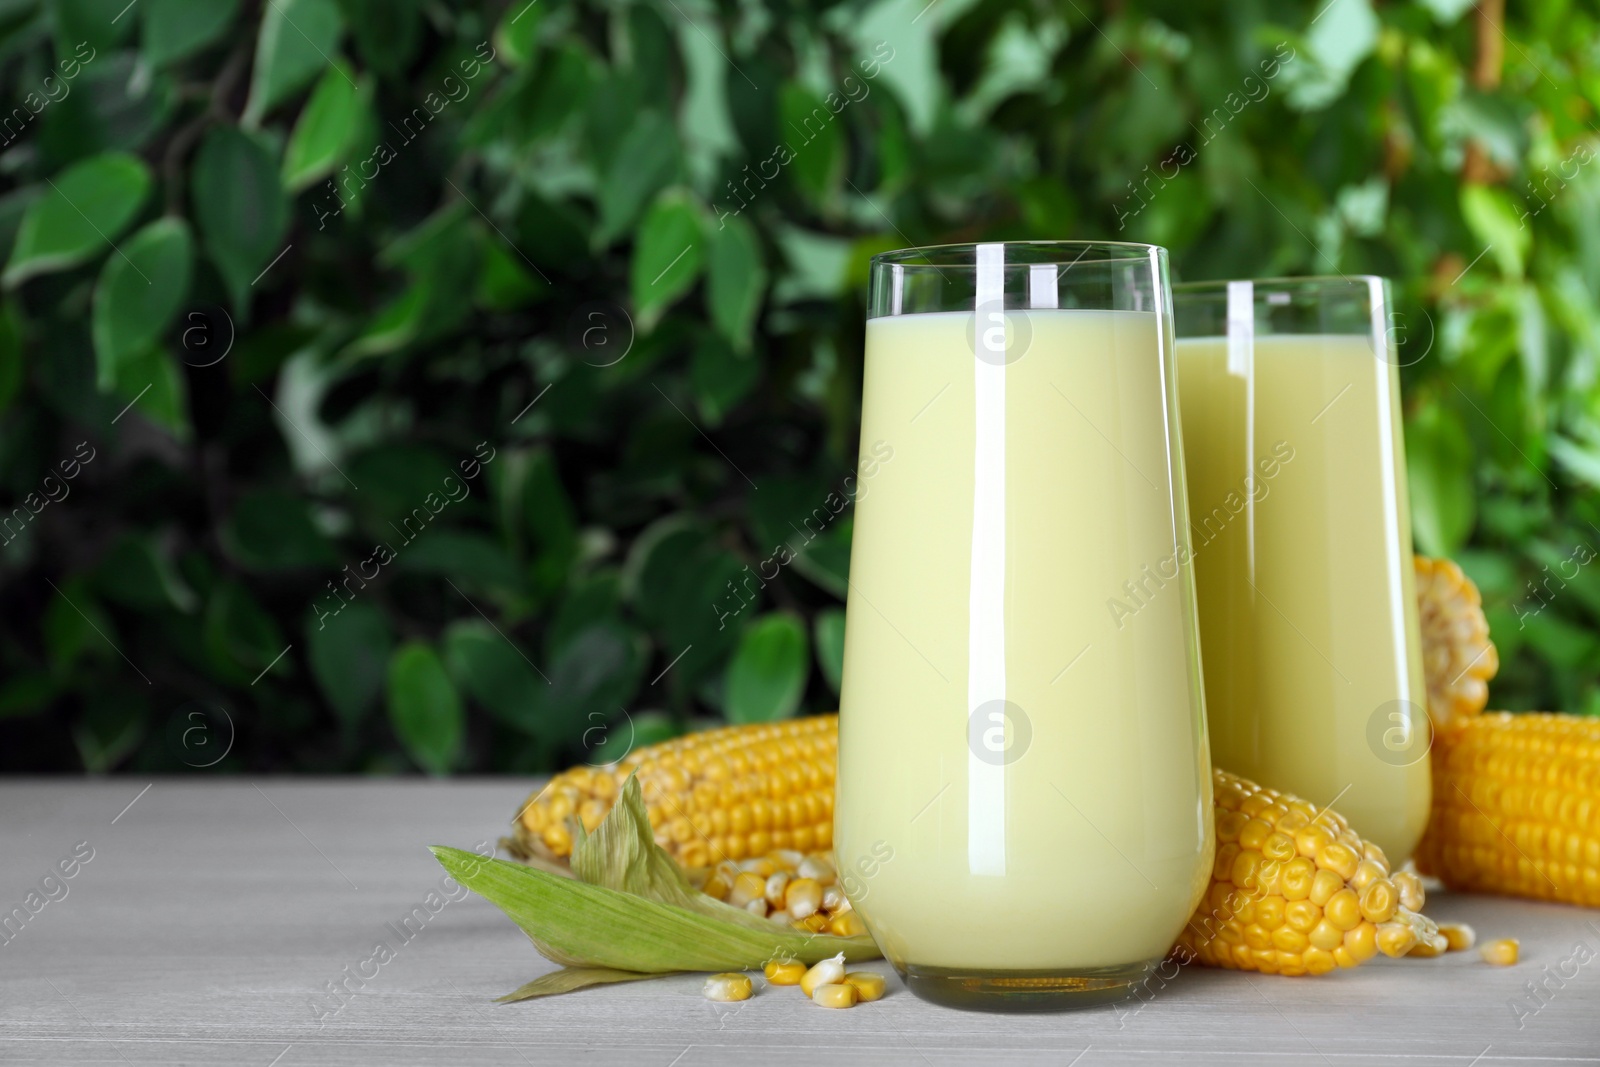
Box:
835;310;1213;973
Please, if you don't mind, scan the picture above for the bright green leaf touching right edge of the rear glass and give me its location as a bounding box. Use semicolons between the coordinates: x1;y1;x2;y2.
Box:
1405;403;1475;558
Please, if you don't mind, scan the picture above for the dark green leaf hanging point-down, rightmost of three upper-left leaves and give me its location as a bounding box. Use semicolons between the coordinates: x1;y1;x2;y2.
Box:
194;126;288;309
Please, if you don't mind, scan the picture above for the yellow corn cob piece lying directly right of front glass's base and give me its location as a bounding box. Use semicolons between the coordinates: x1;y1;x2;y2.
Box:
1176;771;1445;976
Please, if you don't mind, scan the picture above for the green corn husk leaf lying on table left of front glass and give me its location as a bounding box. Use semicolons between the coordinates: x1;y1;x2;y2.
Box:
432;779;880;997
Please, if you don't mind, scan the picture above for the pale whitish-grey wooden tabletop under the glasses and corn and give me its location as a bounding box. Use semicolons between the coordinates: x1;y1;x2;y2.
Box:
0;779;1600;1067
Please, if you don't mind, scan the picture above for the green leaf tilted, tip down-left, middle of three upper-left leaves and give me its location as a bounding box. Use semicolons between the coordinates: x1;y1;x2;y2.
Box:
91;216;194;390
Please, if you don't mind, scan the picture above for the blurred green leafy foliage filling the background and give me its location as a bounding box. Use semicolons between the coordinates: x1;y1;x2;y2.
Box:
0;0;1600;773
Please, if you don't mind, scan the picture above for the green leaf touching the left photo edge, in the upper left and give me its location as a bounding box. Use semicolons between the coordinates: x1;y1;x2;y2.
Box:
3;152;150;286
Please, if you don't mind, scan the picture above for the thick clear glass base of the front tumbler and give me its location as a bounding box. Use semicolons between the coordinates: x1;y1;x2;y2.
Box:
901;960;1160;1011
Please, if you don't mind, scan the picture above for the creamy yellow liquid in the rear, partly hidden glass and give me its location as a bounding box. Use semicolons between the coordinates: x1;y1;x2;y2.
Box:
1178;334;1429;864
